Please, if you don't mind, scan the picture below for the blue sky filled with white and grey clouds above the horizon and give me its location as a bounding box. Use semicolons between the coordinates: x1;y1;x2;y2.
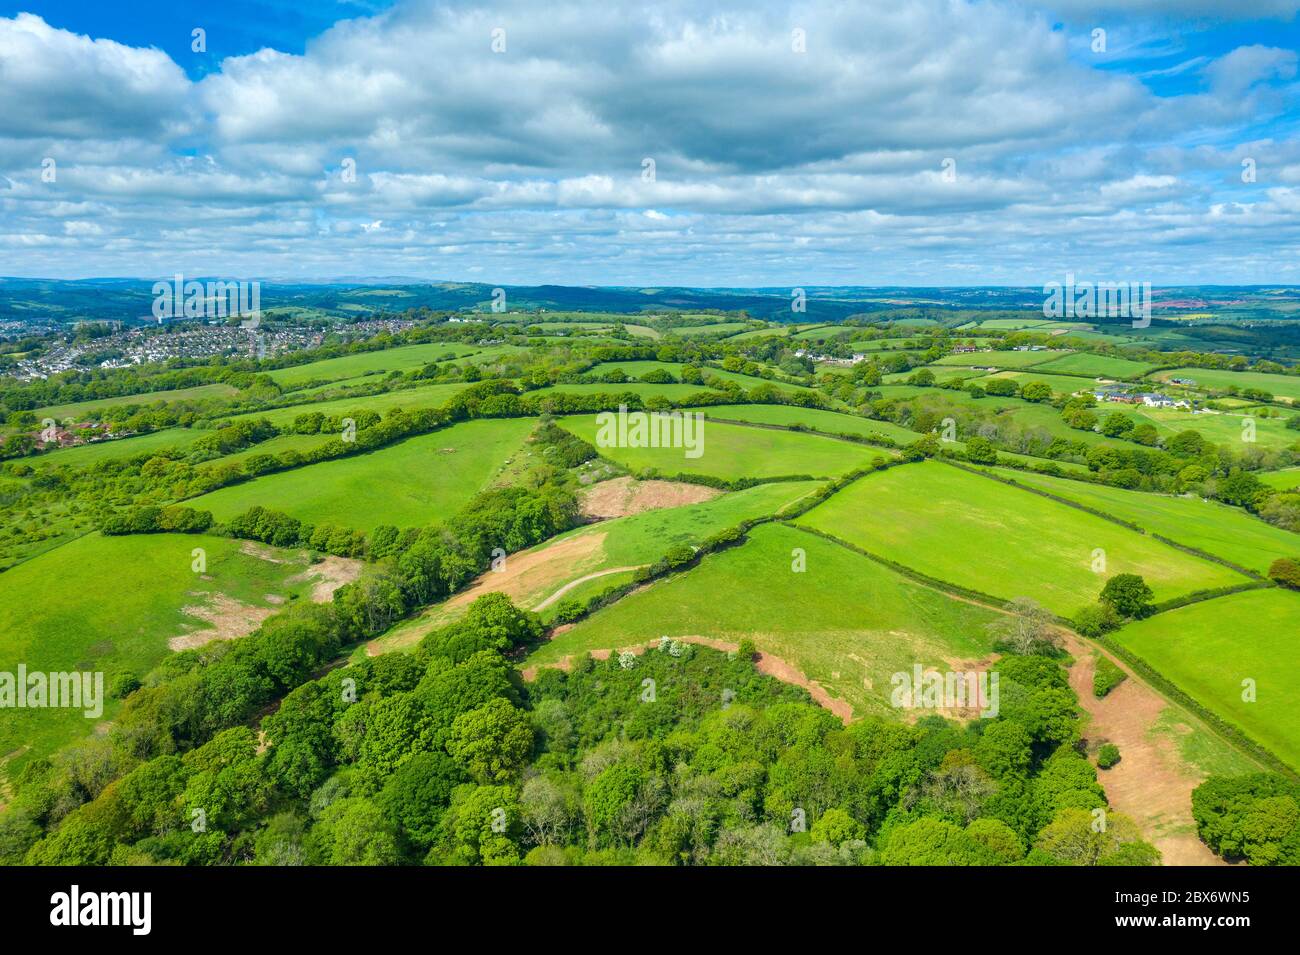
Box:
0;0;1300;286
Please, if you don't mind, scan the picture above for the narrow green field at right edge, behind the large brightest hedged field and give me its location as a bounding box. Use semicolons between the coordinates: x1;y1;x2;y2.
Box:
995;468;1300;574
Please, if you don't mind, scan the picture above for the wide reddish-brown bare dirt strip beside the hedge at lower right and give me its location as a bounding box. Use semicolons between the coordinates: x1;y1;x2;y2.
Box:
1066;635;1225;865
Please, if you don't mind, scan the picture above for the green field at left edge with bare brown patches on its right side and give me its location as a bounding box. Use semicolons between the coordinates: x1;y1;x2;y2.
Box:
0;534;311;772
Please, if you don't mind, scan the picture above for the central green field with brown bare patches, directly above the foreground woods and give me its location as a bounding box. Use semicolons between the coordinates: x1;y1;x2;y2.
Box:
527;525;996;716
